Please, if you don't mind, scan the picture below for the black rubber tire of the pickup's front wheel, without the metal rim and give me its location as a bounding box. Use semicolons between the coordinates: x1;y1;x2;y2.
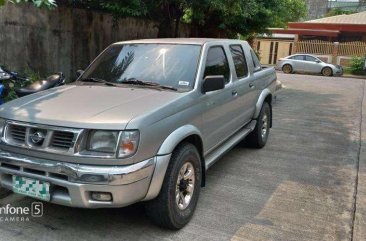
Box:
145;143;202;230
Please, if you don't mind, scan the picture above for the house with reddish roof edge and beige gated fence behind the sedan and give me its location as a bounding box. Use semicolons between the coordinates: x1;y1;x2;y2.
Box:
255;11;366;66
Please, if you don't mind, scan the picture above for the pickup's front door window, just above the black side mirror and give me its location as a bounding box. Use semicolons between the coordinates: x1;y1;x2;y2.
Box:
204;46;230;83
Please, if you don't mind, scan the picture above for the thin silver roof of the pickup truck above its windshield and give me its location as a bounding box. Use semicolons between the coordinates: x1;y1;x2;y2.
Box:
115;38;247;45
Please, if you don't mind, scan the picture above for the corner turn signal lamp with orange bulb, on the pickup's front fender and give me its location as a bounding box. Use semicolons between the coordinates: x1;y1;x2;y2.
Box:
118;131;140;158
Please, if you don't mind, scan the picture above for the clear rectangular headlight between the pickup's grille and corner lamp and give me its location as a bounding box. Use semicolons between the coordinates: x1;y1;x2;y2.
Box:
86;130;119;153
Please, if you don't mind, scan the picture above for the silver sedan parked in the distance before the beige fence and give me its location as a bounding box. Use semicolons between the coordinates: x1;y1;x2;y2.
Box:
276;54;343;76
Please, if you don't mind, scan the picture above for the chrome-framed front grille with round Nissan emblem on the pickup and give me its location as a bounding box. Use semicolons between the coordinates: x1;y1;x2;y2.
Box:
4;122;81;152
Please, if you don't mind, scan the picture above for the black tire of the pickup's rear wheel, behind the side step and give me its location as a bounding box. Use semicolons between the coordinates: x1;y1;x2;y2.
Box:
246;102;272;149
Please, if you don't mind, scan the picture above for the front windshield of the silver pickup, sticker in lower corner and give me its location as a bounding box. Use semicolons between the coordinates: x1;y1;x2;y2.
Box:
81;44;201;91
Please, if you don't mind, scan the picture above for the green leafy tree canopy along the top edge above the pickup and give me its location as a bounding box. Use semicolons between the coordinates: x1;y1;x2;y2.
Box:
0;0;307;38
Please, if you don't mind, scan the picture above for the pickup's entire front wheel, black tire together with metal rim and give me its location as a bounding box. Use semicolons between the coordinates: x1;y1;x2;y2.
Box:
145;143;202;230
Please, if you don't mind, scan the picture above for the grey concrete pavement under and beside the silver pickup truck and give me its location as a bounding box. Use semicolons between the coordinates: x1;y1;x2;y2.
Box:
0;74;366;241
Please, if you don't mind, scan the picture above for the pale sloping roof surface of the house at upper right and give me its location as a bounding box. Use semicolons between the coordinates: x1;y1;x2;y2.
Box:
305;11;366;25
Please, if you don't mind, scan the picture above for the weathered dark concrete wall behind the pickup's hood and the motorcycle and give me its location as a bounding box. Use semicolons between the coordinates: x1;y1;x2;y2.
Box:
0;3;189;79
